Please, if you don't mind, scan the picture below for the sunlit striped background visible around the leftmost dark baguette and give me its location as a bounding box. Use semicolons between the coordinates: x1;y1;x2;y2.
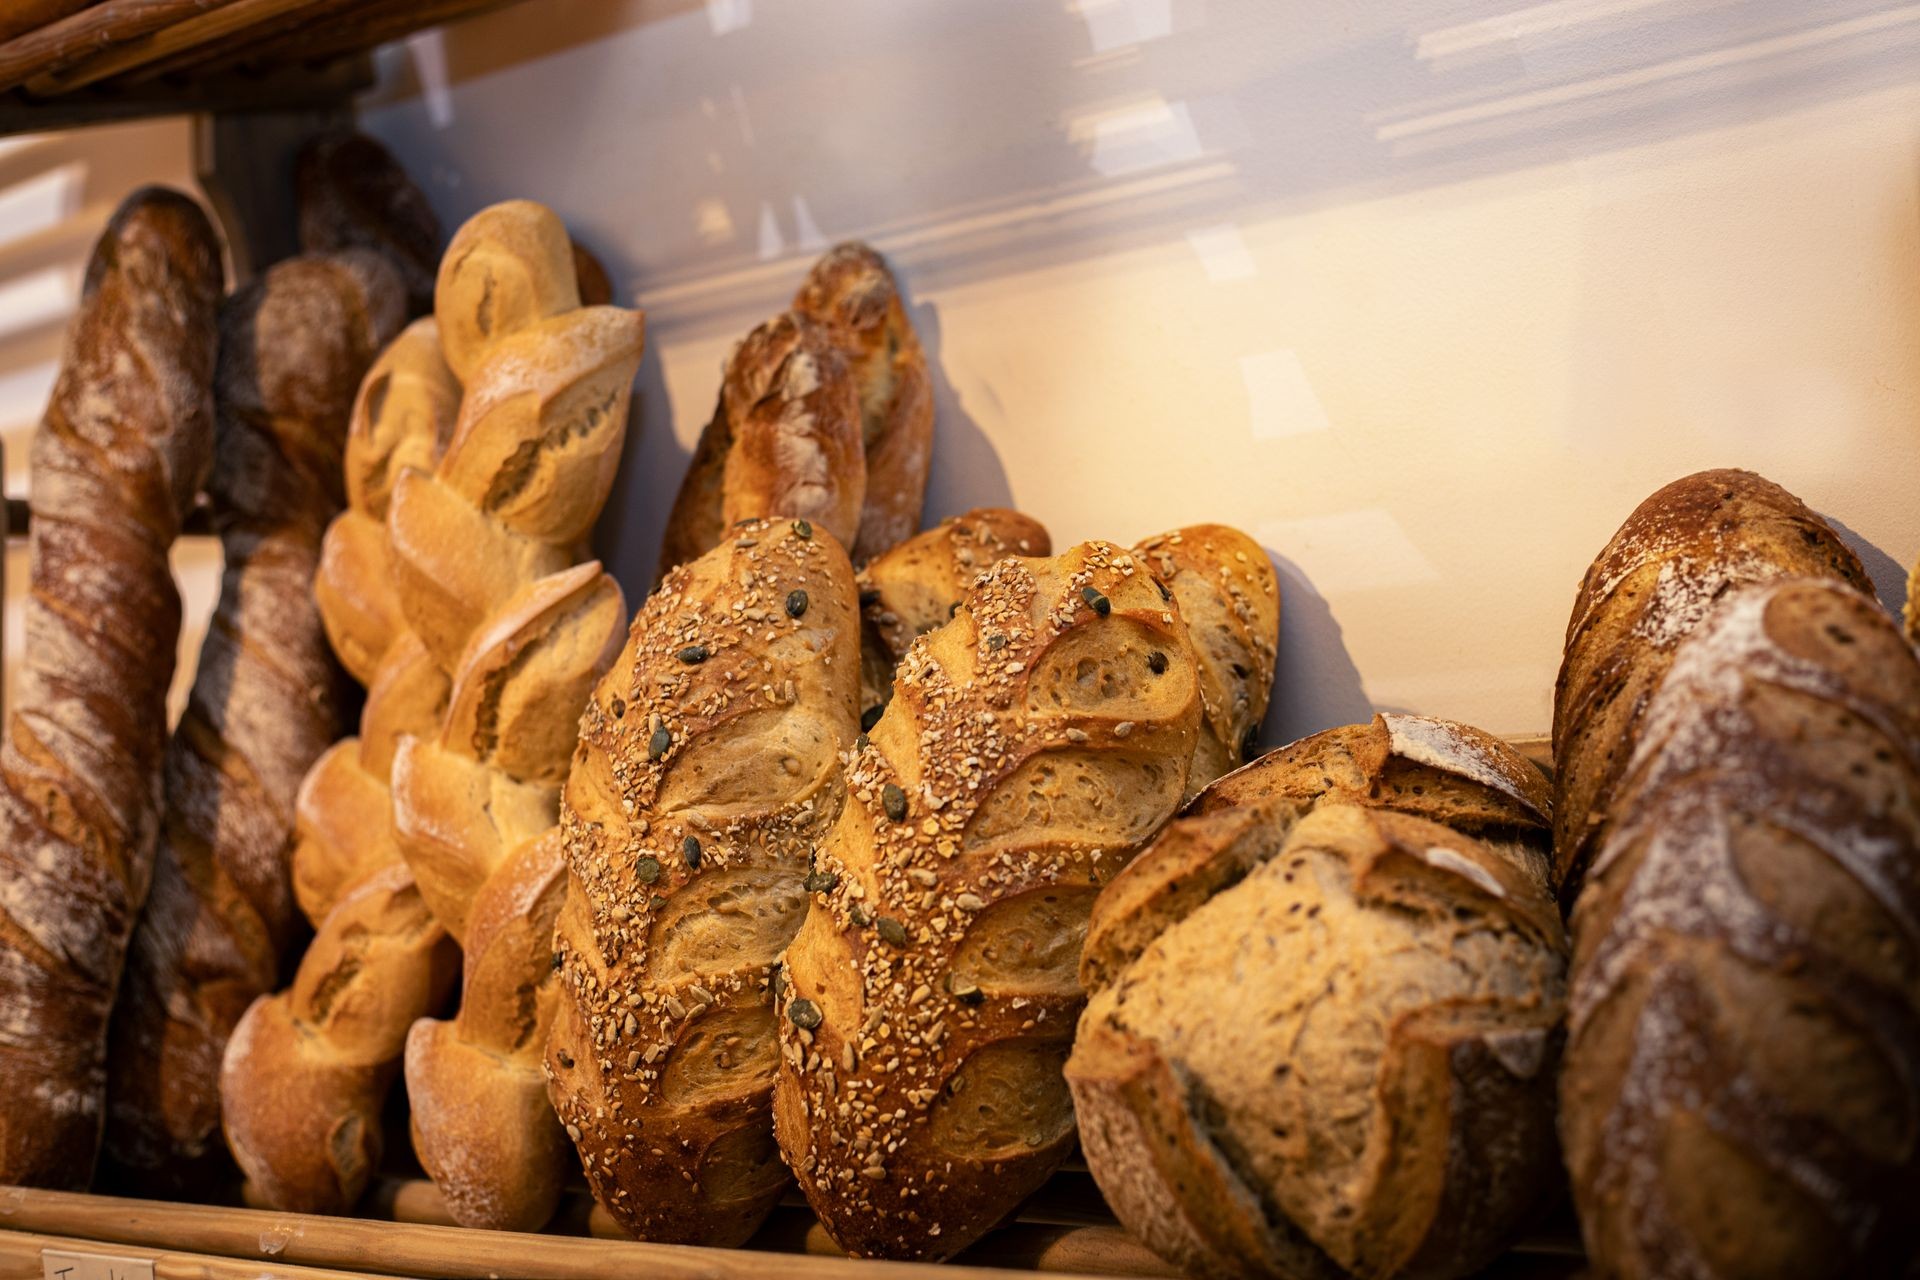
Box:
0;119;221;716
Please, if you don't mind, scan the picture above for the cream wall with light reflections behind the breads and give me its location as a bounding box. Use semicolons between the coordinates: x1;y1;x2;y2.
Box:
341;0;1920;741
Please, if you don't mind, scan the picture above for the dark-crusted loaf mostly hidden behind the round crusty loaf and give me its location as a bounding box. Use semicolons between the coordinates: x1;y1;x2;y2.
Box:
1081;714;1549;990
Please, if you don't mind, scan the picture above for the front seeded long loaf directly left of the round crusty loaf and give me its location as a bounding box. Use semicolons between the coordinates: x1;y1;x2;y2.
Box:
774;543;1200;1257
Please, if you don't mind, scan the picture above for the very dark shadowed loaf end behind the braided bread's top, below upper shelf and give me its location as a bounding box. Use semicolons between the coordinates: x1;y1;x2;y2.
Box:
294;130;440;315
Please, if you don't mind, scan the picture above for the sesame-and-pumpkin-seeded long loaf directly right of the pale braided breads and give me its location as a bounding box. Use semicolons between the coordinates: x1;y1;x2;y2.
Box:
547;520;860;1245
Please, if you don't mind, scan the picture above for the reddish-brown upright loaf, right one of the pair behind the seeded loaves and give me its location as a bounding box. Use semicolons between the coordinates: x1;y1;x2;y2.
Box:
793;242;933;564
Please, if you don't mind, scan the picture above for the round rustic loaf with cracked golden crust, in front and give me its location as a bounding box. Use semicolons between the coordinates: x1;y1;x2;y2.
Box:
1068;802;1567;1280
